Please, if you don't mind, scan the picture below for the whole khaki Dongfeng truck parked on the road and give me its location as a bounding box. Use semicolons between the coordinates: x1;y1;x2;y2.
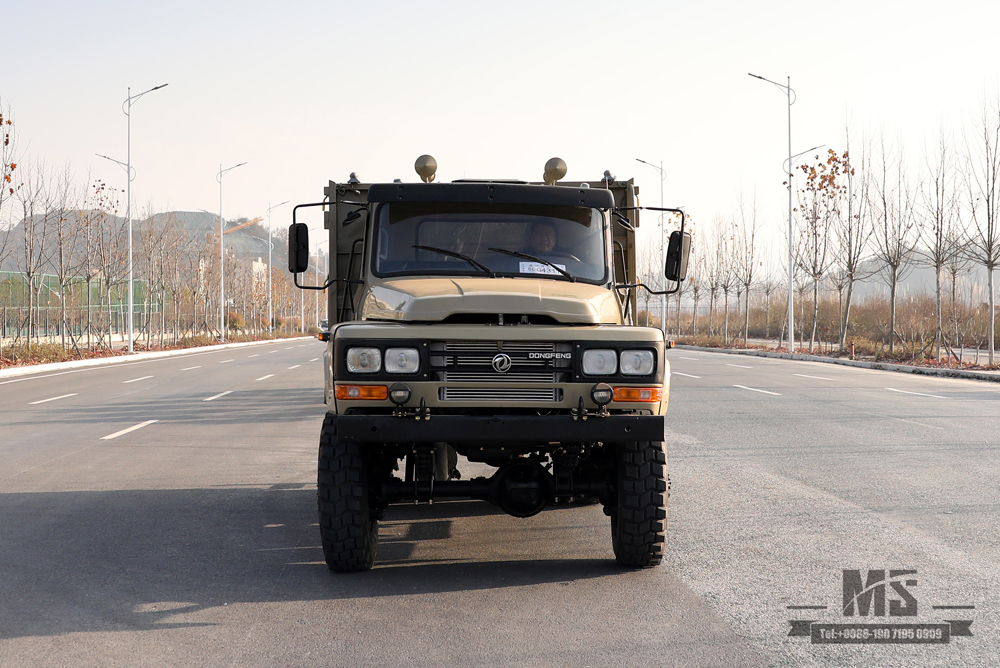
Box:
288;156;690;571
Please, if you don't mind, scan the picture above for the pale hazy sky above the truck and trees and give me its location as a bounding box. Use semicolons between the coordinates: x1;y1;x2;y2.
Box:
0;0;1000;260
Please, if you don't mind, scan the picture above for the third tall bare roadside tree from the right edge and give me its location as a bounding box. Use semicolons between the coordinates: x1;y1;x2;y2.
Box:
869;135;919;355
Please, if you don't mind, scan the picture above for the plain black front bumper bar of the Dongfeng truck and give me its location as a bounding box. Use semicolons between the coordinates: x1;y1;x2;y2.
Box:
334;415;665;445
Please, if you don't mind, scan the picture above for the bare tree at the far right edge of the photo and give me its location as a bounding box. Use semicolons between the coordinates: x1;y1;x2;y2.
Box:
966;98;1000;366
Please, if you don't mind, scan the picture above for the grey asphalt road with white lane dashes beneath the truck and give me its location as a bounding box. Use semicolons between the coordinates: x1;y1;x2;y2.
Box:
0;342;1000;667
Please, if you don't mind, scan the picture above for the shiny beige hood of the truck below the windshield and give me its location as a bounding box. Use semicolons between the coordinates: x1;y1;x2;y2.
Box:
361;277;621;325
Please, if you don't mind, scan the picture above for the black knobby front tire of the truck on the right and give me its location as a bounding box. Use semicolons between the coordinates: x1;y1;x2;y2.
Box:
611;441;667;568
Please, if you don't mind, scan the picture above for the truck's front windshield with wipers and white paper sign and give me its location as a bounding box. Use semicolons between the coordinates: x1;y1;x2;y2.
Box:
373;202;607;283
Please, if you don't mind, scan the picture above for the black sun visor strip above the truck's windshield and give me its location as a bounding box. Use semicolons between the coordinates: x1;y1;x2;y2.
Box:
368;182;615;209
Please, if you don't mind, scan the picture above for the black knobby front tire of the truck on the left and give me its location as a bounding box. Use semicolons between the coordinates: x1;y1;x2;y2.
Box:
317;415;378;573
